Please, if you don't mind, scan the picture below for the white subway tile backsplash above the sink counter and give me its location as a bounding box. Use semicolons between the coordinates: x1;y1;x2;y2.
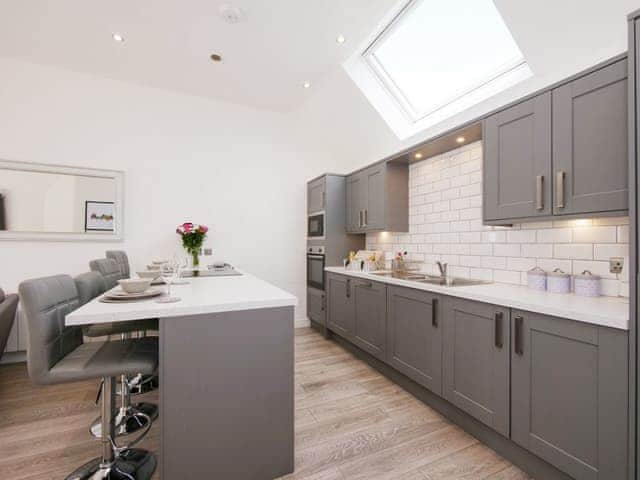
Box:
366;142;629;296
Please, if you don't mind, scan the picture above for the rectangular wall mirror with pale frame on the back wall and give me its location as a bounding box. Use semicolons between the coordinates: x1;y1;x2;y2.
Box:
0;160;124;241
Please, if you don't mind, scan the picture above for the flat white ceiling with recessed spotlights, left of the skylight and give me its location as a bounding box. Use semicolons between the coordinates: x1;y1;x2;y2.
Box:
0;0;397;111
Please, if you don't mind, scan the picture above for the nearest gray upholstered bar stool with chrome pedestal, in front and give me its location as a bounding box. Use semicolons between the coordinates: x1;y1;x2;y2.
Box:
19;275;158;480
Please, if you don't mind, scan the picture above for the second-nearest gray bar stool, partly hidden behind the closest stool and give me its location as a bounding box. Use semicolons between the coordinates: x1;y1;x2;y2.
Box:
74;272;158;437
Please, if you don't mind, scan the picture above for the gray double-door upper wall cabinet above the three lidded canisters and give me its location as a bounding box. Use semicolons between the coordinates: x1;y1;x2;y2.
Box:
483;59;628;224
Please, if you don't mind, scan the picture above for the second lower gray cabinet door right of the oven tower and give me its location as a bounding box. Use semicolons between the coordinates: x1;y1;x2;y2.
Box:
353;279;387;360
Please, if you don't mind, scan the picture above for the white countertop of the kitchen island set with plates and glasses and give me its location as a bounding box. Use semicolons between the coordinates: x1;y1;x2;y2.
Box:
65;273;298;325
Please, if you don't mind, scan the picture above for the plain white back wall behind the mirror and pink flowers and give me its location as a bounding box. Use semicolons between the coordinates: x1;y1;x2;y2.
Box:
0;60;338;352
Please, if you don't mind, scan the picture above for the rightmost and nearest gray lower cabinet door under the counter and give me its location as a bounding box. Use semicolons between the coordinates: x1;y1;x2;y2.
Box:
511;310;628;480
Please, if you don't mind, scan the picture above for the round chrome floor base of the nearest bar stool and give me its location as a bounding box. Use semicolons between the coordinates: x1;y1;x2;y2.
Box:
65;448;157;480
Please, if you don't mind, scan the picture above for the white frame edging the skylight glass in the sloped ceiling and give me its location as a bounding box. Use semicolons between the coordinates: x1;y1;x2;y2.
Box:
361;0;529;124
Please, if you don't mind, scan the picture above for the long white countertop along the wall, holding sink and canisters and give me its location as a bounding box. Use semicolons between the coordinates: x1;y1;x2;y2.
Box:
325;267;629;330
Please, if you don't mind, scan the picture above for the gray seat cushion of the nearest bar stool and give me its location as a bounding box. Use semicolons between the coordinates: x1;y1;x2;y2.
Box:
51;337;158;383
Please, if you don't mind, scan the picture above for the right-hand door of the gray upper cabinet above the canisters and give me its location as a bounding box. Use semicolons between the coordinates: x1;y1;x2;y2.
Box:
553;60;629;215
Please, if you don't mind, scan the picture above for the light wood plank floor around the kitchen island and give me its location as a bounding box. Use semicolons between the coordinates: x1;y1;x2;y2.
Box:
0;329;528;480
